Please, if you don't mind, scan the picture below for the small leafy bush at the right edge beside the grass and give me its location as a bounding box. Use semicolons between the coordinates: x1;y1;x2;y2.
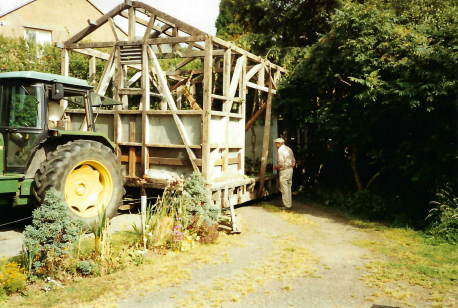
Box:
427;188;458;244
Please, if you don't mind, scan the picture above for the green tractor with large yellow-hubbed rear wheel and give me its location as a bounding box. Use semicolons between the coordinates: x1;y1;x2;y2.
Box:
0;72;125;223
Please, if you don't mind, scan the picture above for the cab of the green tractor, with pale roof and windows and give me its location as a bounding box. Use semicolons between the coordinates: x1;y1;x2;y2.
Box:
0;72;95;173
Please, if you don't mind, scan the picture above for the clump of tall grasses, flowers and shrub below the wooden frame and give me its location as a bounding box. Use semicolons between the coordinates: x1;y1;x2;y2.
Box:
133;173;220;251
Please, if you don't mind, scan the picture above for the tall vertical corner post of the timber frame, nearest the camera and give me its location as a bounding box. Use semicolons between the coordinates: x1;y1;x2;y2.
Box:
202;36;213;180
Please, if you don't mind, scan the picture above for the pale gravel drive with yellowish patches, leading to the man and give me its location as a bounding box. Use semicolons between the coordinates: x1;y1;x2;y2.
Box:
117;199;408;308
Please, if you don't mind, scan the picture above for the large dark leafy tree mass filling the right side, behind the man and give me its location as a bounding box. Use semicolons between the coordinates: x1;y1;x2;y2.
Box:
275;0;458;221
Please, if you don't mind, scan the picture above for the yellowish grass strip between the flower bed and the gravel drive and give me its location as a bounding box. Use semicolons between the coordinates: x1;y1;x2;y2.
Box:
4;232;240;308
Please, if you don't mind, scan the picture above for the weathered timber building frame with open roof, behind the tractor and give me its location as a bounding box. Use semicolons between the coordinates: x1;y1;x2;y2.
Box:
58;0;285;206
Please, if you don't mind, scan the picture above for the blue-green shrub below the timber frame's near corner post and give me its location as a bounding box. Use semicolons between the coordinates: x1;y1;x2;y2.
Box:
183;172;220;226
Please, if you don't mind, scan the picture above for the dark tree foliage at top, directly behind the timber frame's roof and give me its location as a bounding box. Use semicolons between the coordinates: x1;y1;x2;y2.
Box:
216;0;340;64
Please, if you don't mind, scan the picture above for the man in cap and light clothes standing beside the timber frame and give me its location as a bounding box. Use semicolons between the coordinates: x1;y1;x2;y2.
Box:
274;138;296;209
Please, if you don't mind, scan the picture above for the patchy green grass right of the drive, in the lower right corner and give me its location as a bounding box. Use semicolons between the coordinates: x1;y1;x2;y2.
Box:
353;221;458;307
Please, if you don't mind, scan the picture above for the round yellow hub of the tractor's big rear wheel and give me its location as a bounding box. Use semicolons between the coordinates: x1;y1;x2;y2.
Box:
65;160;113;218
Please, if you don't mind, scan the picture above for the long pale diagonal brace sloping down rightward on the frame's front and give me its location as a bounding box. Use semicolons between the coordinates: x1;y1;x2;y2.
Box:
147;46;200;172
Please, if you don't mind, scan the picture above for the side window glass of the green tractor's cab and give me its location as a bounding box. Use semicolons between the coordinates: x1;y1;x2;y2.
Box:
0;85;43;128
